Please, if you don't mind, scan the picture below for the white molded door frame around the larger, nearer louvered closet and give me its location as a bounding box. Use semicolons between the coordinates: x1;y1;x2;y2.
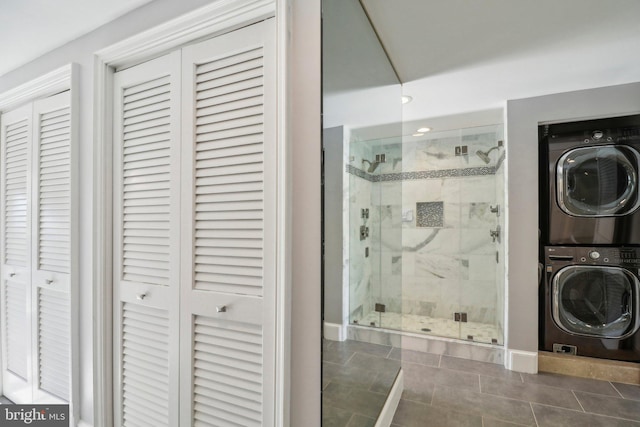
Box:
93;0;291;426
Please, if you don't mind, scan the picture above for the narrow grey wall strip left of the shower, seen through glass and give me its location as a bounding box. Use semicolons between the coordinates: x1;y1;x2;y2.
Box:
322;126;345;325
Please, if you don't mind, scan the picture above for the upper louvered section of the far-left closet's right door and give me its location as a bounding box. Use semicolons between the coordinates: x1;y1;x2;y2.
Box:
38;107;71;274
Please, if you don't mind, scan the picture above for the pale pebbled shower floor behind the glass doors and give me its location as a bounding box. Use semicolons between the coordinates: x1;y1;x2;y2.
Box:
358;311;503;345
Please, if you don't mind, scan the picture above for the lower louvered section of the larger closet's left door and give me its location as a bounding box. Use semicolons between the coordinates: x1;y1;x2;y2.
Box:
121;303;169;427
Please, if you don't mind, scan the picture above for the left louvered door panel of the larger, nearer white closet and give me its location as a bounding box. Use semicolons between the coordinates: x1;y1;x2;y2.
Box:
113;52;180;427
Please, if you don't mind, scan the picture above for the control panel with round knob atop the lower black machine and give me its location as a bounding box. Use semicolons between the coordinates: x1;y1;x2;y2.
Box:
545;246;640;267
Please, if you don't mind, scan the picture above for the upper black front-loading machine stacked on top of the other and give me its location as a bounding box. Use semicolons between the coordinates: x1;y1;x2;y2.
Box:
539;115;640;246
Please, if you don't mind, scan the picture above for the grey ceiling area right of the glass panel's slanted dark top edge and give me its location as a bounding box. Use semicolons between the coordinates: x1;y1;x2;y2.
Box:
361;0;640;83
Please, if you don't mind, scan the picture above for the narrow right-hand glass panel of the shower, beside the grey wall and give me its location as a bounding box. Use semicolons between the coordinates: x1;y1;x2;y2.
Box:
460;125;504;344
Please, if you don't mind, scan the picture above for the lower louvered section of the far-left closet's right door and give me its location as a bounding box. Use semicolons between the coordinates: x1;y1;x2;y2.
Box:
38;288;71;402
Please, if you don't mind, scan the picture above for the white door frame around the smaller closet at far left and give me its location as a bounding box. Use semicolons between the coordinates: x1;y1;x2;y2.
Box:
0;63;80;424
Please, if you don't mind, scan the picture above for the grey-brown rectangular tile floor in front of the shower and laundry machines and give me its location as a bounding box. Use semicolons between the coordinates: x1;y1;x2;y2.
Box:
322;341;640;427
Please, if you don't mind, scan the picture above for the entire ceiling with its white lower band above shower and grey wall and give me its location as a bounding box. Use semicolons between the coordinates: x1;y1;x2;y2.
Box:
323;0;640;134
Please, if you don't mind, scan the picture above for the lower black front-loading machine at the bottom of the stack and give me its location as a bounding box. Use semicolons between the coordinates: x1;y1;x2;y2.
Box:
541;246;640;362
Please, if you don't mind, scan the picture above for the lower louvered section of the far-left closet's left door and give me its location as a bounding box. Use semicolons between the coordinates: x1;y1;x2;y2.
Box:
4;280;27;380
